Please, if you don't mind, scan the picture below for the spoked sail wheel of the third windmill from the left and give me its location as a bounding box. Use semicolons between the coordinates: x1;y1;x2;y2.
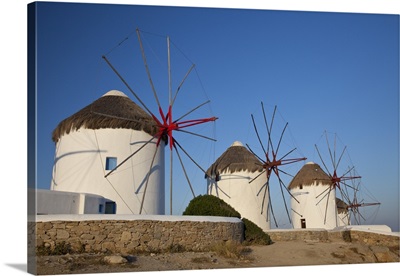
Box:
315;131;361;224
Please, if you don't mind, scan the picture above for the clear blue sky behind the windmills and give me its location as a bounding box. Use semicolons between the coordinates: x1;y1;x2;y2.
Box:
33;3;399;231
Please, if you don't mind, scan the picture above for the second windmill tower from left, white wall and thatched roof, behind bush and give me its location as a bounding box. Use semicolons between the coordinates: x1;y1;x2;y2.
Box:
206;141;270;231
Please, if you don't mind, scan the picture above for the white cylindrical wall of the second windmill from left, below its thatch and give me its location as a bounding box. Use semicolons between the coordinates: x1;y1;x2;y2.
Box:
207;171;271;231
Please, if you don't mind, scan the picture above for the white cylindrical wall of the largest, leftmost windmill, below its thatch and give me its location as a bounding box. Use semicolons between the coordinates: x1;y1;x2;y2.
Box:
51;128;165;214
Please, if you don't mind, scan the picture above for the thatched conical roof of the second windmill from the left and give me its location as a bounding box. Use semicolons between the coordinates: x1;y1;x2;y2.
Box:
206;142;263;176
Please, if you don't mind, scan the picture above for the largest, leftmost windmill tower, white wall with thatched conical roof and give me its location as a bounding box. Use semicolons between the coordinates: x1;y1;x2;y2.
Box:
51;90;165;214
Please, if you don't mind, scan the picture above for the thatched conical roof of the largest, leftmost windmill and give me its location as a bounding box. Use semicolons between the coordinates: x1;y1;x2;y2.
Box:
52;90;157;142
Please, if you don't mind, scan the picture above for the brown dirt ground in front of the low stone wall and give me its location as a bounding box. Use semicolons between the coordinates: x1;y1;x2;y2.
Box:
37;241;399;275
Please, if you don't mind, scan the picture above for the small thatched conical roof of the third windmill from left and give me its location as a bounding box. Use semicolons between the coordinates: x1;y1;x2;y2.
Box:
288;162;331;189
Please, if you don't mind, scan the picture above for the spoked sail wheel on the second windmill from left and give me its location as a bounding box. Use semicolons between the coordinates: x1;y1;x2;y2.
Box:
246;102;306;227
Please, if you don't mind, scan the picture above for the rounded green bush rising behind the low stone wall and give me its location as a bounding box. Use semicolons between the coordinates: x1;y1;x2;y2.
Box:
183;195;241;218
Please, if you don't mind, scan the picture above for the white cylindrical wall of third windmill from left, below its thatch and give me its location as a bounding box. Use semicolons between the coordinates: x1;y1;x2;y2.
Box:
290;181;338;229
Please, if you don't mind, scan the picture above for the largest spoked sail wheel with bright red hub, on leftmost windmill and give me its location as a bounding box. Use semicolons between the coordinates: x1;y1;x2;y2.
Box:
103;29;217;214
